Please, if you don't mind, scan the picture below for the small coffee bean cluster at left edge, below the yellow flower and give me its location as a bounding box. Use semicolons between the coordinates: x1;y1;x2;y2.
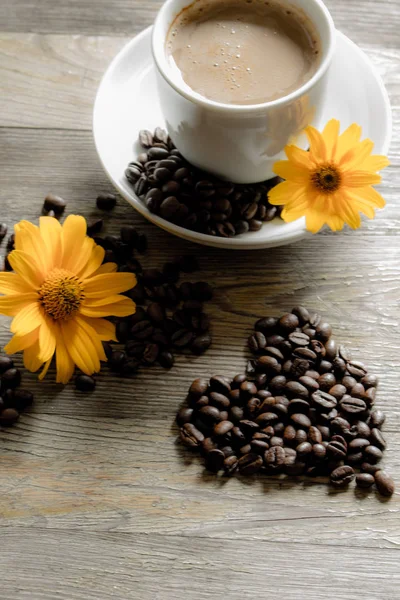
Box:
0;356;33;427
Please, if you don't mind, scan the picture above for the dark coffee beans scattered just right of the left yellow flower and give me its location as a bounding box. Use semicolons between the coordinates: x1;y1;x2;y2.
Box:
75;213;213;392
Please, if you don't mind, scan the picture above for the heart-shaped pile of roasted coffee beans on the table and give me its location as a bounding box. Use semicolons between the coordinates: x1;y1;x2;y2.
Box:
177;307;394;496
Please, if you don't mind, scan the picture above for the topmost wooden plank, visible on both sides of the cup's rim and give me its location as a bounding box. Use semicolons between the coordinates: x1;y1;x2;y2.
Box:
0;0;400;47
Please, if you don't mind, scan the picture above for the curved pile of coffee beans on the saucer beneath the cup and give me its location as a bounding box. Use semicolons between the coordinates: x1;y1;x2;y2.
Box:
125;127;281;238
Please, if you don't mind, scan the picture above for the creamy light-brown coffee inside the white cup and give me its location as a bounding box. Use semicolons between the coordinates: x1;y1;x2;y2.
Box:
166;0;320;105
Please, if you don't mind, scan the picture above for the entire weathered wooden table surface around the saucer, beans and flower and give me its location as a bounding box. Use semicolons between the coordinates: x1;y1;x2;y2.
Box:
0;0;400;600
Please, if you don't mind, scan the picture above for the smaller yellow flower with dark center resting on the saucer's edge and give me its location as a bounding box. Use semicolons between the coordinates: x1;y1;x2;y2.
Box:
269;119;389;233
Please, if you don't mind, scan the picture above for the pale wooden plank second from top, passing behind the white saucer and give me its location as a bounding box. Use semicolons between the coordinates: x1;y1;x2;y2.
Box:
0;33;400;130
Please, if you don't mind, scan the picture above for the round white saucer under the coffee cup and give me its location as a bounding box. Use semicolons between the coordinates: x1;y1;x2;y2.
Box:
93;28;392;250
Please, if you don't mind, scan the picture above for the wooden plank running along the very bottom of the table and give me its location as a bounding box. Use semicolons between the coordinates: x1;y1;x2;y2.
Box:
0;529;400;600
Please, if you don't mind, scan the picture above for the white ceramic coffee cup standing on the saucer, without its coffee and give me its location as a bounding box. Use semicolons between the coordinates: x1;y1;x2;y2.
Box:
152;0;336;183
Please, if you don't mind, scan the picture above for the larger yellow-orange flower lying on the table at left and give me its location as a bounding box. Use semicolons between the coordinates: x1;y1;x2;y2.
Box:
0;215;136;383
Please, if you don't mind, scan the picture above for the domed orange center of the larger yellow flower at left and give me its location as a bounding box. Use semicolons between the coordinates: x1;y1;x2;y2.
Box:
39;269;84;321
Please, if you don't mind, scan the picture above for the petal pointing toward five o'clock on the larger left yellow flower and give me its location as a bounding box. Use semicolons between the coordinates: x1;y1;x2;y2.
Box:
60;319;100;375
